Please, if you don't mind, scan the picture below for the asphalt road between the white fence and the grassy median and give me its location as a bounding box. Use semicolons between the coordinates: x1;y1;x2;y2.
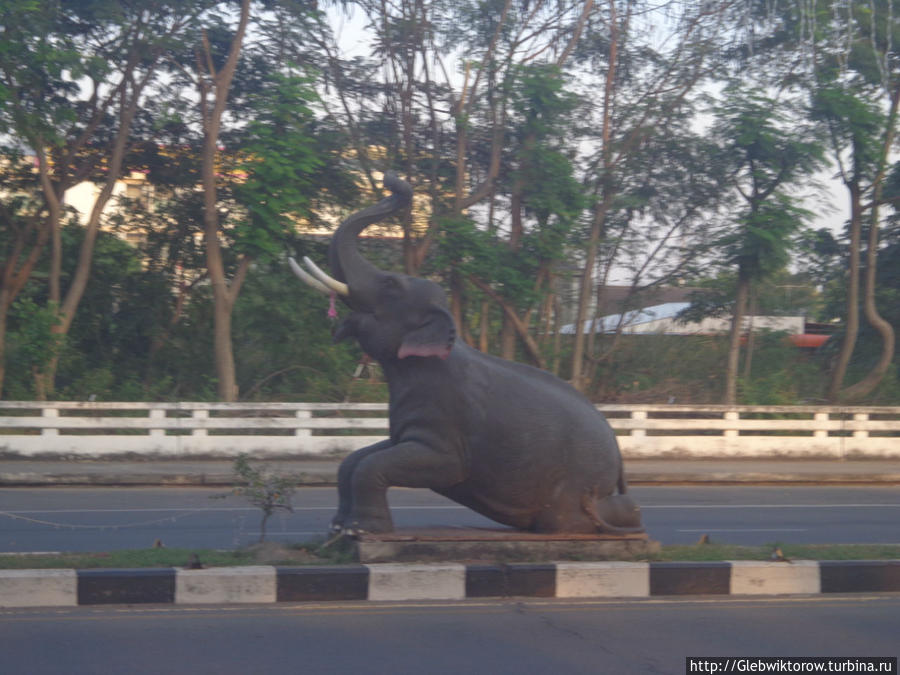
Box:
0;486;900;552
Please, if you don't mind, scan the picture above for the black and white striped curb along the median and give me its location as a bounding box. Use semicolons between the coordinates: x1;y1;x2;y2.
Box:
0;560;900;607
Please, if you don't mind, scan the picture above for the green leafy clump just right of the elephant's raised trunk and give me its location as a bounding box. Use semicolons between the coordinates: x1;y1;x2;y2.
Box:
431;64;587;318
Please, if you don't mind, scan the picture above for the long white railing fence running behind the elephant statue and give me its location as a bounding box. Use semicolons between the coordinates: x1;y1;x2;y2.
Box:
0;401;900;459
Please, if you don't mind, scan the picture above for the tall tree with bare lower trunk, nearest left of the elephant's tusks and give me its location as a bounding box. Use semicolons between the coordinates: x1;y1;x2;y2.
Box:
171;0;338;401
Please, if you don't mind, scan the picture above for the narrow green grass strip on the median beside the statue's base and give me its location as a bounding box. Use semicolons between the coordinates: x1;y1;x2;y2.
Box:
0;543;900;569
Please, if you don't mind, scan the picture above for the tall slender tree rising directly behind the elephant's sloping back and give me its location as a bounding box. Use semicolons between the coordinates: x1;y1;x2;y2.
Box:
571;0;733;390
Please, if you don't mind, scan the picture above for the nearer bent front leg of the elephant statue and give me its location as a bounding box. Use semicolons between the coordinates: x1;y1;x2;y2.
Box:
344;441;464;532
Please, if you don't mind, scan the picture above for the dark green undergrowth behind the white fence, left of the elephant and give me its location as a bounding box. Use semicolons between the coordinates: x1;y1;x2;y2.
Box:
6;226;366;401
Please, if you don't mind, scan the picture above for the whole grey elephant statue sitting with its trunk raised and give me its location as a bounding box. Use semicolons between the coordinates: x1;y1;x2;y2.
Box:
290;173;643;536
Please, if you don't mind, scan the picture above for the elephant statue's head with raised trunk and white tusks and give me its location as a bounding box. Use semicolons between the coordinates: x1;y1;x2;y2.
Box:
290;173;456;362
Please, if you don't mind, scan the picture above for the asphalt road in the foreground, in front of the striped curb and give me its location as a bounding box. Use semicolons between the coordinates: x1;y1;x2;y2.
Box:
0;594;900;675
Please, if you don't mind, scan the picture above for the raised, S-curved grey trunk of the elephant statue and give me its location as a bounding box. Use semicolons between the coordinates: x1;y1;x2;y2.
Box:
328;172;412;302
